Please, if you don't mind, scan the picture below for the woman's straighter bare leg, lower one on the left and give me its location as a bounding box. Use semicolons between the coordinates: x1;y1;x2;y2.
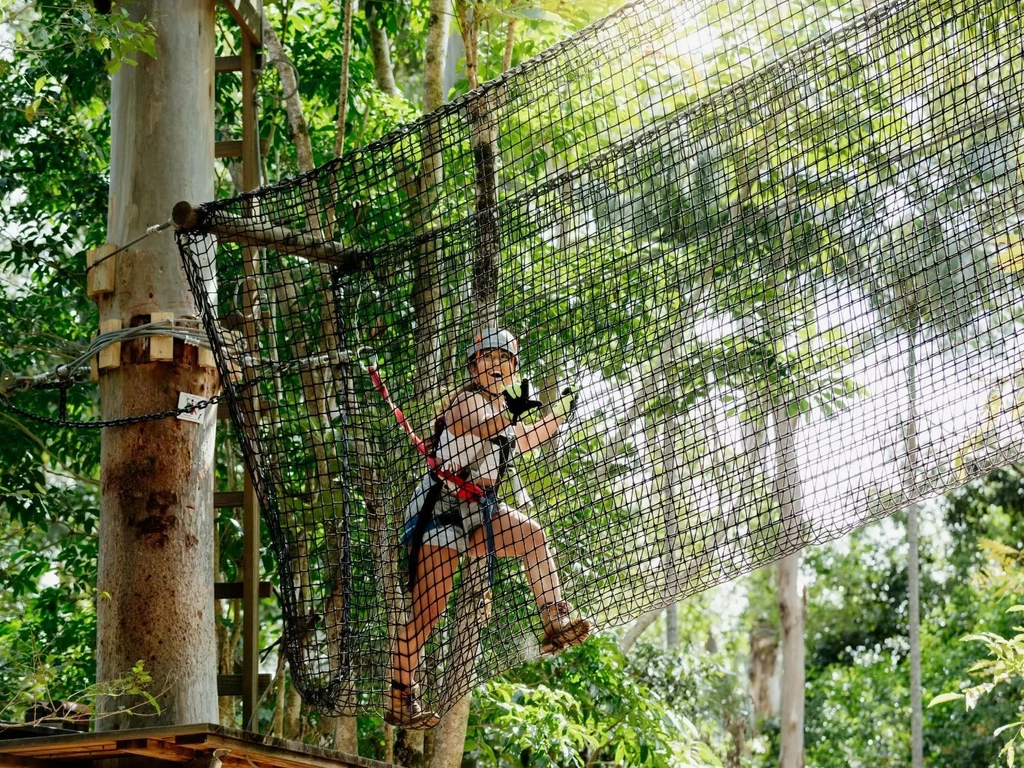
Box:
392;544;460;687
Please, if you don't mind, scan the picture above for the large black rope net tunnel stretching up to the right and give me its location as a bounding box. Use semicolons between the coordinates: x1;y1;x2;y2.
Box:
178;0;1024;722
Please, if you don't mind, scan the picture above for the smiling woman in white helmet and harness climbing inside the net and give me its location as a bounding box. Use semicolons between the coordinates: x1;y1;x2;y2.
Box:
385;329;591;728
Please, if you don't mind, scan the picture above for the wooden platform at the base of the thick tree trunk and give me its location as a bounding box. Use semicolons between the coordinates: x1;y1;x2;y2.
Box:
0;723;391;768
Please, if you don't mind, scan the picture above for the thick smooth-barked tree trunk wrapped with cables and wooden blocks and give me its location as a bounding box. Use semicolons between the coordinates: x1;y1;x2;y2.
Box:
96;0;219;730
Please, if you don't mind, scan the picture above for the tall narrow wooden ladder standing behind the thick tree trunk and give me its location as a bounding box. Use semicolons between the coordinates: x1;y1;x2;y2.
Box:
213;0;270;730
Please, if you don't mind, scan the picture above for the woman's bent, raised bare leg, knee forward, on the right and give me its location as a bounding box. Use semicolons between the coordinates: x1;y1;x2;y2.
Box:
469;507;562;608
